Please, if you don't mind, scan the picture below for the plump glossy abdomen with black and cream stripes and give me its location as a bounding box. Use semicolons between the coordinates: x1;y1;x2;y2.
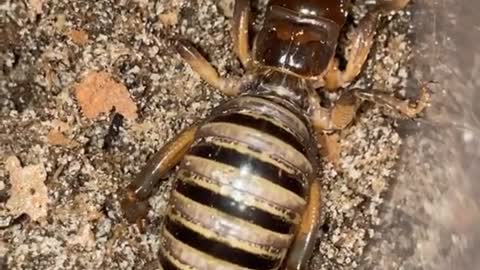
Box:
160;96;314;270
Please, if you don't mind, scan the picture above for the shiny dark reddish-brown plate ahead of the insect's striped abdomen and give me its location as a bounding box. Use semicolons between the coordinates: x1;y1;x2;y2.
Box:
254;0;347;78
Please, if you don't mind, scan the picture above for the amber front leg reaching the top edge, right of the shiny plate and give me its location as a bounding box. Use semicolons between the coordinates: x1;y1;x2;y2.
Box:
324;0;410;90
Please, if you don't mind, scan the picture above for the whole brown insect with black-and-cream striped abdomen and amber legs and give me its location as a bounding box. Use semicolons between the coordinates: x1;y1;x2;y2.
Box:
122;0;428;270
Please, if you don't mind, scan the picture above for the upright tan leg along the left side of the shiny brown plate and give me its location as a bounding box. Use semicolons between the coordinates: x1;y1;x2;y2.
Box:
232;0;252;69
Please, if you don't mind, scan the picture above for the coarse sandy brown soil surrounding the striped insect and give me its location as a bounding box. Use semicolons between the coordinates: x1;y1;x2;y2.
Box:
0;0;438;270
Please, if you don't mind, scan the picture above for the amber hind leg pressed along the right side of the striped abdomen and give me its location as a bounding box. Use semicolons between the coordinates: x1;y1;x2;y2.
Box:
286;179;322;270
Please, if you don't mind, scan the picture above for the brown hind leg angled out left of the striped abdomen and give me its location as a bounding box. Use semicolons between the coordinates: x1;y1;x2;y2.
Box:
121;126;197;223
